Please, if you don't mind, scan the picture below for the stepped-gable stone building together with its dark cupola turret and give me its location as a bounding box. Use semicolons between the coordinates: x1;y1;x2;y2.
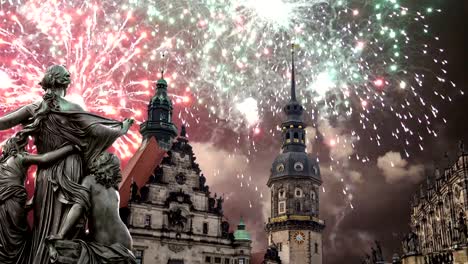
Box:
123;74;251;264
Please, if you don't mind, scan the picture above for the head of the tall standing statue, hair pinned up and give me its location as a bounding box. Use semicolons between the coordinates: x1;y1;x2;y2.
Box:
39;65;71;96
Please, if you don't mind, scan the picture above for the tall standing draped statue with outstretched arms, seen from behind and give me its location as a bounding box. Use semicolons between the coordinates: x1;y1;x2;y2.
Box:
0;65;133;264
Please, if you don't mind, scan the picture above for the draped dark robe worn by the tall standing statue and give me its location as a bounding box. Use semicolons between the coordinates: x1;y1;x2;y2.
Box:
28;104;122;264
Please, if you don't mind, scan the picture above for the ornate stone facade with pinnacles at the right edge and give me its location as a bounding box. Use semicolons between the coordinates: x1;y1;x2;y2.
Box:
403;143;468;261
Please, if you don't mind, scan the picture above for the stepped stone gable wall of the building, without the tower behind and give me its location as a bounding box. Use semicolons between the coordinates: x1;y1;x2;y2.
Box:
127;137;251;264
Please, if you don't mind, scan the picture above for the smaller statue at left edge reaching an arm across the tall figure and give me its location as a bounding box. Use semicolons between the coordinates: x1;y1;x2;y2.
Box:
0;137;74;264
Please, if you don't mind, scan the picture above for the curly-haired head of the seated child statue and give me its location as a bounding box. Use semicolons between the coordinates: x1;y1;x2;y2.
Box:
89;151;122;190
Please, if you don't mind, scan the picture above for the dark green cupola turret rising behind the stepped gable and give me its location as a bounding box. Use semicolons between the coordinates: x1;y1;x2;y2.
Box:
140;72;177;150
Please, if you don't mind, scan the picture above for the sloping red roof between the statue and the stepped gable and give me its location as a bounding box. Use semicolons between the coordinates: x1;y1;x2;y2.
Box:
119;137;166;207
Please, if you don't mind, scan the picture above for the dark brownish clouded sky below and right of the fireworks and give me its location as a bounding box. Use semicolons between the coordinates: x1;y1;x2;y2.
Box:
191;0;468;264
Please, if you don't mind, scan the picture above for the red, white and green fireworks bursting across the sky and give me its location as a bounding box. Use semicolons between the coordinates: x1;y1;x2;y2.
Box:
0;0;454;205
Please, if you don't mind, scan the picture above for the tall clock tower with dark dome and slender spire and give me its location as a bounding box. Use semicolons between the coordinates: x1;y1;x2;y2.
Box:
266;46;325;264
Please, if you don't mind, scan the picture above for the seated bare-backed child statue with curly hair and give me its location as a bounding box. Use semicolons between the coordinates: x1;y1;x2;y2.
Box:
48;152;136;264
